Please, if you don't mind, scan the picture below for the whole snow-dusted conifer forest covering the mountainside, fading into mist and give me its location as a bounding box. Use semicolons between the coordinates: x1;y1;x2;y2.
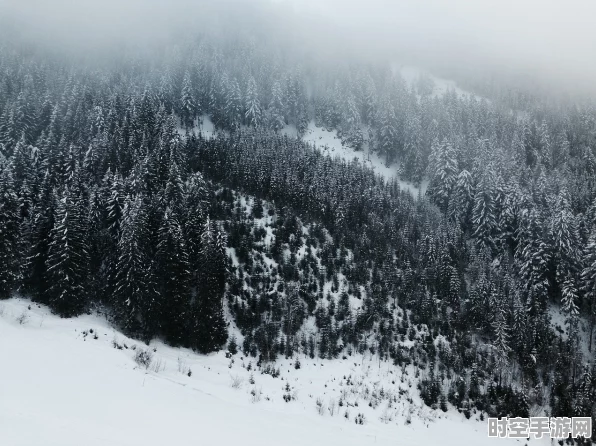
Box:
0;28;596;436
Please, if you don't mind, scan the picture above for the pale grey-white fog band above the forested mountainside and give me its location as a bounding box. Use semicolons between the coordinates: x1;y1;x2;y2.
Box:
0;0;596;94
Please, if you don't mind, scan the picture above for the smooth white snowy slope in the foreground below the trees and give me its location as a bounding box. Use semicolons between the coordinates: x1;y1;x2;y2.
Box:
0;299;544;446
